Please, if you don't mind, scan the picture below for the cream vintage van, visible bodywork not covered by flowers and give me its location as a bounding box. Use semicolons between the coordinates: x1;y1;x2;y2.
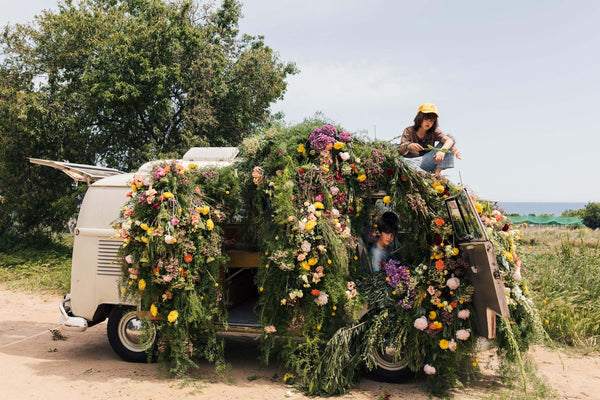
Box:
30;147;508;374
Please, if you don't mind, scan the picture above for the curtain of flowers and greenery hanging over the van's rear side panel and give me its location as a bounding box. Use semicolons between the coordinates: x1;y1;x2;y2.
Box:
115;163;240;374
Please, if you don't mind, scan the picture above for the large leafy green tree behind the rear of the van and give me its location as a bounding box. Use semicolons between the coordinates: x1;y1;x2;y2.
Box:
0;0;296;236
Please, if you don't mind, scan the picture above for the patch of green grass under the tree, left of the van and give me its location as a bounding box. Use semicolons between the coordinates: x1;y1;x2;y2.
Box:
0;235;73;295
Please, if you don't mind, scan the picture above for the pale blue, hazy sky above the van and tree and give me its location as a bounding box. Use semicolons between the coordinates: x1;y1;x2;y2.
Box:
0;0;600;202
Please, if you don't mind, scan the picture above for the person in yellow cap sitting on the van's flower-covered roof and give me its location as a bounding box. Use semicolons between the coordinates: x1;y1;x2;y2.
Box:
399;103;460;173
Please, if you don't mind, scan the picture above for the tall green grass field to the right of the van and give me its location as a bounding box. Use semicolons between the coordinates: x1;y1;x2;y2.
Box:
522;228;600;352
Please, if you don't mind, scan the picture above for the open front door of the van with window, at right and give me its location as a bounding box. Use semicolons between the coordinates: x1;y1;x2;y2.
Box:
446;189;509;339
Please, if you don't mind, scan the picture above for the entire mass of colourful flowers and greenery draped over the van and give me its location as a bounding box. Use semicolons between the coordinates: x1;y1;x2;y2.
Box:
112;119;537;395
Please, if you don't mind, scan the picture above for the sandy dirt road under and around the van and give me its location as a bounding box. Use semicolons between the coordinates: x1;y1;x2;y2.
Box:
0;290;600;400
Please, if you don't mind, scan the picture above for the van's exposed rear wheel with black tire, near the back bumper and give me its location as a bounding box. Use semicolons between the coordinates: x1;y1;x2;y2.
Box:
106;306;156;363
